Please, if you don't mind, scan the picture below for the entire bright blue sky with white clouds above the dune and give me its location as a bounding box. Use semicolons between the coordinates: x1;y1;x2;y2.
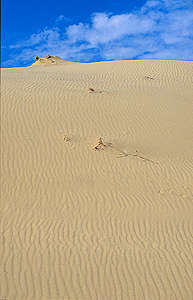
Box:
1;0;193;67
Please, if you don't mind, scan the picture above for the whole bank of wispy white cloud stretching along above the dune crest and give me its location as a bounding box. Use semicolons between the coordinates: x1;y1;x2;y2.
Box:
1;0;193;66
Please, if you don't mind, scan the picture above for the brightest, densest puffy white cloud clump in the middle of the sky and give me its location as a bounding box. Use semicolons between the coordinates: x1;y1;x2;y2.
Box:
67;13;155;45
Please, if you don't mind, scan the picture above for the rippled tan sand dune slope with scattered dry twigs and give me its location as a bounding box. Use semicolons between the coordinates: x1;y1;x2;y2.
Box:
0;57;193;300
